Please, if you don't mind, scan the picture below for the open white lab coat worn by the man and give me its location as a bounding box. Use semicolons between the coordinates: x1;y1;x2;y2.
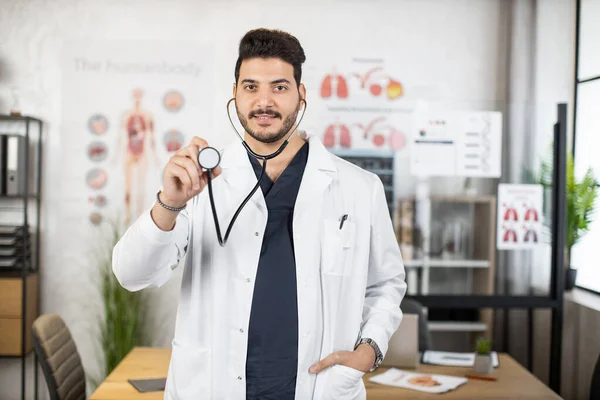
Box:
113;132;406;400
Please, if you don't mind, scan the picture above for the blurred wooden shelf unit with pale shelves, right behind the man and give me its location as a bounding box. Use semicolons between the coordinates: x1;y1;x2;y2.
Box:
394;196;496;341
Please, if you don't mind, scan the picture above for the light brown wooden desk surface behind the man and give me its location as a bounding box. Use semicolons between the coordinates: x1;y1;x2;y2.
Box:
90;347;560;400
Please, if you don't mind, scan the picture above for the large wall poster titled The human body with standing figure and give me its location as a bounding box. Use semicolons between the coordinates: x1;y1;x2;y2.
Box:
61;41;214;233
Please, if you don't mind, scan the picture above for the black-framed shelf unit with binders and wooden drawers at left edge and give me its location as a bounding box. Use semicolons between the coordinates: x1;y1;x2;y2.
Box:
0;115;44;399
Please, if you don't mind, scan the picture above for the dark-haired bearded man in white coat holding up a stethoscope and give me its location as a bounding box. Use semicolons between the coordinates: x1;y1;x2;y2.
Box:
113;29;406;400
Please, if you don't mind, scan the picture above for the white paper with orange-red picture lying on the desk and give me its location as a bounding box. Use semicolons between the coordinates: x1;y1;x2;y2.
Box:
369;368;467;393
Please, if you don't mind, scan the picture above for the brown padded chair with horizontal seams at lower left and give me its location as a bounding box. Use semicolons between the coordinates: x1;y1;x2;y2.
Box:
32;314;86;400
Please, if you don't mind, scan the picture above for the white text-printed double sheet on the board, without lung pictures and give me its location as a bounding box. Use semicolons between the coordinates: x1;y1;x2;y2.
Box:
410;108;502;177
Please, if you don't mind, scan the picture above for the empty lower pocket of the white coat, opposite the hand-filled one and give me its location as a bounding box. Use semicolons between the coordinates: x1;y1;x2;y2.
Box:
169;341;212;400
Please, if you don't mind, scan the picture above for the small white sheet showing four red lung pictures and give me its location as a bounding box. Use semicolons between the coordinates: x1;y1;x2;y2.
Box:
496;184;543;250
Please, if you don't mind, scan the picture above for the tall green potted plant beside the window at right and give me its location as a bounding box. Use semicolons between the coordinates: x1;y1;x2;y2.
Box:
537;152;600;290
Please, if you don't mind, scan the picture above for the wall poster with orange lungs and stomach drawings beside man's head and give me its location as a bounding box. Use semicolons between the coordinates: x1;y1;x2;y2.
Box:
309;57;410;152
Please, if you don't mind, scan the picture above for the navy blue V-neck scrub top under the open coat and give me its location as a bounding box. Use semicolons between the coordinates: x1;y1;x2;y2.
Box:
246;143;308;400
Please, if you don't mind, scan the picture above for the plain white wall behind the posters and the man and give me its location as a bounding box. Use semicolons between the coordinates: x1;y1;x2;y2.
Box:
0;0;571;399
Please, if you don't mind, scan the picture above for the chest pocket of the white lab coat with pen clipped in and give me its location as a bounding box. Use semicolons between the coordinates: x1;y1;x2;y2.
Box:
321;219;356;276
